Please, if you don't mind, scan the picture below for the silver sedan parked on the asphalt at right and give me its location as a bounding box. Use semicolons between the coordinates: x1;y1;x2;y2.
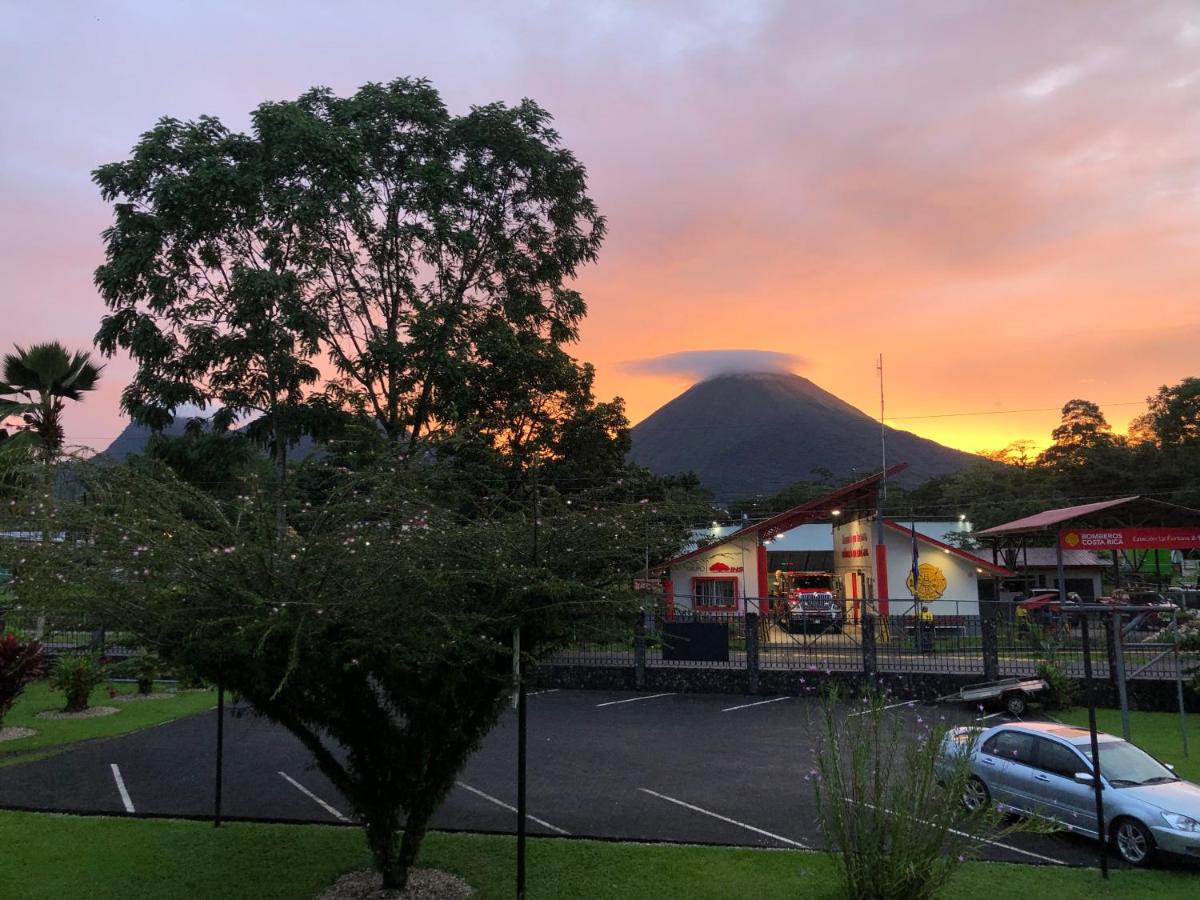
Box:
942;722;1200;865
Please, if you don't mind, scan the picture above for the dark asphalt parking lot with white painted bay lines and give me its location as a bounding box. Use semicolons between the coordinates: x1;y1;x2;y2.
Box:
0;690;1142;865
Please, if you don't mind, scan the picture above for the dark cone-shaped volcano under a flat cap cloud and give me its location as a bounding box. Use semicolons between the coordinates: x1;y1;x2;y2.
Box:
629;372;978;500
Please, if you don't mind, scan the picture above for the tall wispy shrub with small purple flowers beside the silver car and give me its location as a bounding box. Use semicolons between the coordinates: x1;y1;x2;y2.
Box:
809;694;1020;900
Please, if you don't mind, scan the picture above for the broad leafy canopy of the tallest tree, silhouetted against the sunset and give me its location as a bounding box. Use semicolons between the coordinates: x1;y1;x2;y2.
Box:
95;79;605;482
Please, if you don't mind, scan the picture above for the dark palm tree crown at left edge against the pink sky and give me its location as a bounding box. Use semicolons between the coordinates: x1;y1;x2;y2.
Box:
0;341;103;466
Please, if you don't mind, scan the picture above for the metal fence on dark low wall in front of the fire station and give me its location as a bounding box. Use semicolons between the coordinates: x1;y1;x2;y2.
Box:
550;598;1200;680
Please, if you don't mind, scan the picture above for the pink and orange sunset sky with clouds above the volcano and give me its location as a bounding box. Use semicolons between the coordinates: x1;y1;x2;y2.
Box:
0;0;1200;458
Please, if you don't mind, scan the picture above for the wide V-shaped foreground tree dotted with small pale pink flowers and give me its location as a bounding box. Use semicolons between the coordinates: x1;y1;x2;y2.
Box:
0;464;685;887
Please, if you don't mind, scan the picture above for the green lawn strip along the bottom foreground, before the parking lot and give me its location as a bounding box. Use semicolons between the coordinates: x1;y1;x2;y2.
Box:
0;811;1198;900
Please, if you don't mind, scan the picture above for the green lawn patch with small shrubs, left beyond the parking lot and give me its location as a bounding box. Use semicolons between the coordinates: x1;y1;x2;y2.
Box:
0;680;216;763
